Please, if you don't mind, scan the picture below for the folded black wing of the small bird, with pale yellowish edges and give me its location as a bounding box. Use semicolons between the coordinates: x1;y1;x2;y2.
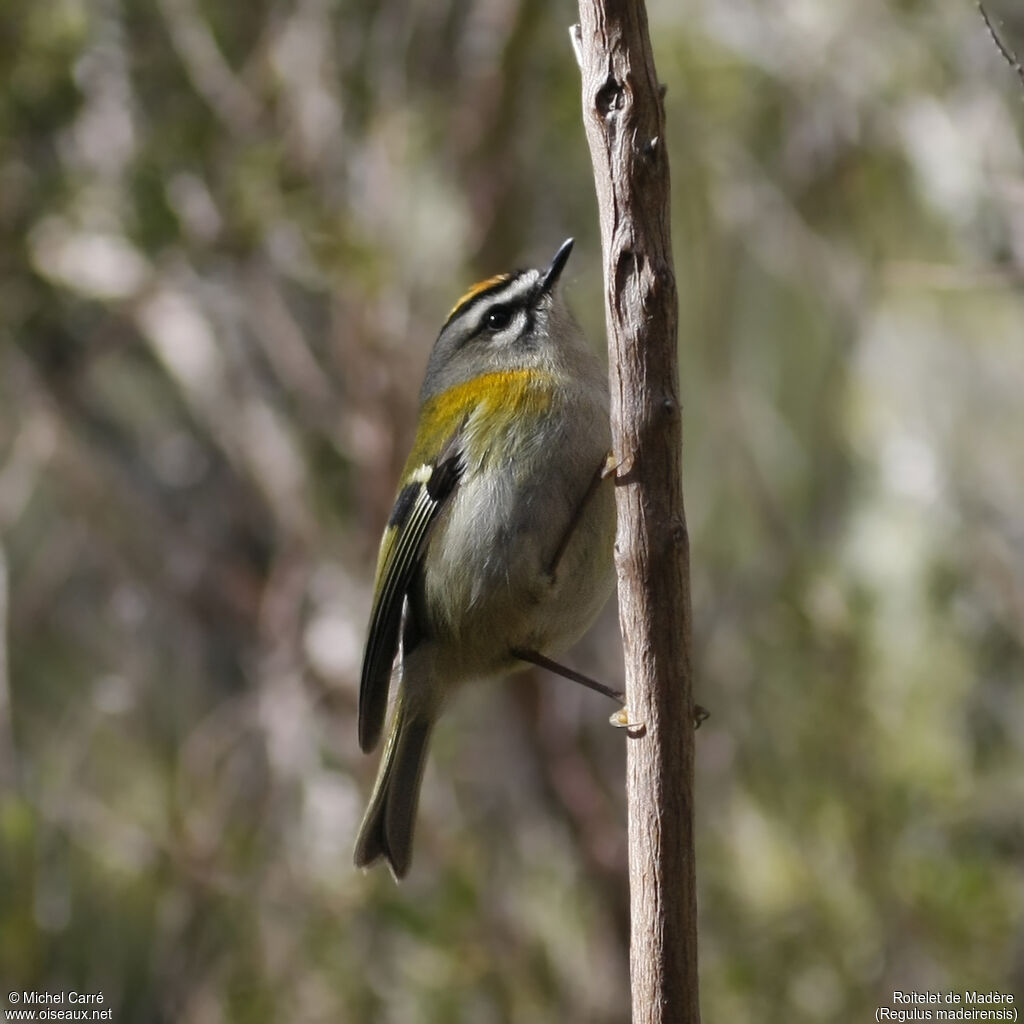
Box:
358;436;462;752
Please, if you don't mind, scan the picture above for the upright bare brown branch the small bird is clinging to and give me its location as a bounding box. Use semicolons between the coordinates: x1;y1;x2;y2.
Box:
574;0;699;1024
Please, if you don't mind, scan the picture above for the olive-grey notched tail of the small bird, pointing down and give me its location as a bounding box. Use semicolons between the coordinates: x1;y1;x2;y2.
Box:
353;698;433;879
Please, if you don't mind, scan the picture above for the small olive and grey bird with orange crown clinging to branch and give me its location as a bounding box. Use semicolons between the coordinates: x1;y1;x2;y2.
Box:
354;239;615;879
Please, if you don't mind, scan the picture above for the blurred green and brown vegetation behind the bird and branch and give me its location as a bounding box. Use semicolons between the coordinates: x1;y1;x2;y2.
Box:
0;0;1024;1024
